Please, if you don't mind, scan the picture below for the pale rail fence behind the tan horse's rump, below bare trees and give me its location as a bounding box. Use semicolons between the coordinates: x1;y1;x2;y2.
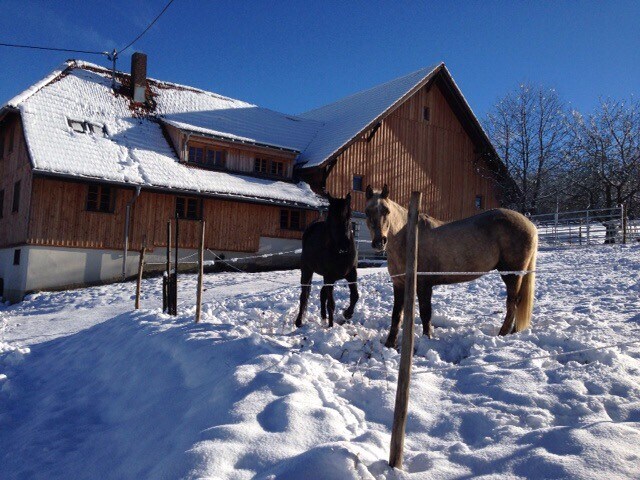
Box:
529;206;640;246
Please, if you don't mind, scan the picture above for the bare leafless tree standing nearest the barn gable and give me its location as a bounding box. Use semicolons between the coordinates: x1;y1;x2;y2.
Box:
487;84;569;213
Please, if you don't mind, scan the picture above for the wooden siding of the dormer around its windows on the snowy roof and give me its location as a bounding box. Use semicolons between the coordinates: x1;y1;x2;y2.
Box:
164;125;295;178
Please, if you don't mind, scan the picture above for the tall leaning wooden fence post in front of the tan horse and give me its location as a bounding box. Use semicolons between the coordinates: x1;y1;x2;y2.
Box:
389;192;422;468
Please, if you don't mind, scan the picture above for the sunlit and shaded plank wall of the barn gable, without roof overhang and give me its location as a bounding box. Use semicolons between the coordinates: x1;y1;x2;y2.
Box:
327;81;499;221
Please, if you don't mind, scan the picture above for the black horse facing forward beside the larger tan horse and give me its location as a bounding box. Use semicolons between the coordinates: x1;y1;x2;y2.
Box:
296;193;359;328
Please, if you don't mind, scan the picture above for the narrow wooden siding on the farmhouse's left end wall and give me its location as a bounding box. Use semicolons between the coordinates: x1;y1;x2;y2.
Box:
0;114;32;248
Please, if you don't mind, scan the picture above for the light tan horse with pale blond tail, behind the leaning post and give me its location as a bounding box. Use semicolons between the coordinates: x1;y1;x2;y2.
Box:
365;185;538;348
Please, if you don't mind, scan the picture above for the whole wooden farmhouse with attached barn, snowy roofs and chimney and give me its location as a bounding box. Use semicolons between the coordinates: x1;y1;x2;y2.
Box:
0;53;511;301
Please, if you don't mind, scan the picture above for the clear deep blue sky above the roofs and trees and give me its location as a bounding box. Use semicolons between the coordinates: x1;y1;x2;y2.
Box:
0;0;640;118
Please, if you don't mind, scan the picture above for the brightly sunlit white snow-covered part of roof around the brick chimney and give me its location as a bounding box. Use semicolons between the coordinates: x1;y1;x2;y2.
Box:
5;62;323;206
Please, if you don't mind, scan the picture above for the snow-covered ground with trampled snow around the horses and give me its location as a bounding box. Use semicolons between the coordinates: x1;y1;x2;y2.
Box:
0;245;640;480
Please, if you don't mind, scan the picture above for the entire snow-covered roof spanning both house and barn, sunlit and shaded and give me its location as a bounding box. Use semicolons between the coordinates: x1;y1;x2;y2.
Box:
5;61;472;205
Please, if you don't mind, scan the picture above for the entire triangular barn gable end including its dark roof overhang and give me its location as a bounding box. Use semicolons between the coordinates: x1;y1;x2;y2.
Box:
308;70;508;220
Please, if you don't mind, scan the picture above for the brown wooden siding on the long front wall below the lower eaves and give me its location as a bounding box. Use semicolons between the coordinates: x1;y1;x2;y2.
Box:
28;178;317;252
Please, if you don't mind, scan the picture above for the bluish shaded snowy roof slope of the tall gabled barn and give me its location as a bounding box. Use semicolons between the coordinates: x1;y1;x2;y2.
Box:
298;64;441;167
